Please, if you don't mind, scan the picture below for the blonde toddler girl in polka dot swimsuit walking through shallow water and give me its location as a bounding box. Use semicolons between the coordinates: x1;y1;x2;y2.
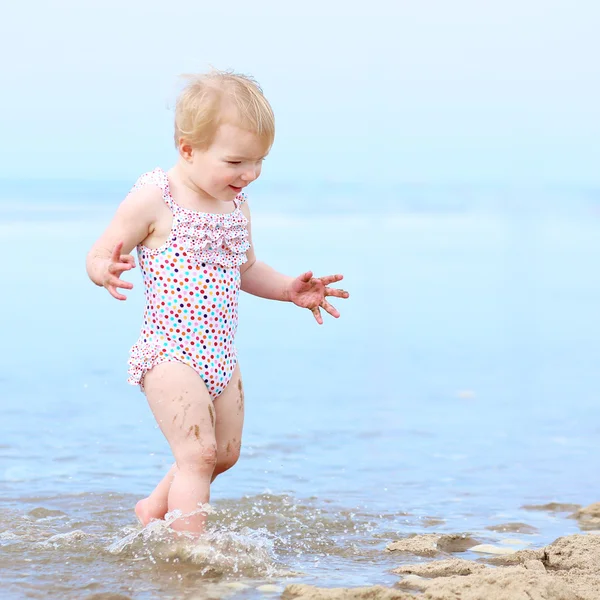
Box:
87;72;348;533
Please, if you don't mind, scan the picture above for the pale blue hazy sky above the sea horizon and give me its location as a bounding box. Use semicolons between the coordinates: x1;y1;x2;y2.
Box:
0;0;600;184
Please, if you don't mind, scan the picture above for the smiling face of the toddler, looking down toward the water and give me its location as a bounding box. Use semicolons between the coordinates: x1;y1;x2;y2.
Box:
186;123;268;201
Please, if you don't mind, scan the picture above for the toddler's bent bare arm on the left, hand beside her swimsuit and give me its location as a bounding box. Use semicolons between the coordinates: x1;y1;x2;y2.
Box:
86;186;164;300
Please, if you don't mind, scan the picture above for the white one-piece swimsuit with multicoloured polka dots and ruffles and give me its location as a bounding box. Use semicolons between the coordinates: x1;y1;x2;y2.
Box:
128;169;250;399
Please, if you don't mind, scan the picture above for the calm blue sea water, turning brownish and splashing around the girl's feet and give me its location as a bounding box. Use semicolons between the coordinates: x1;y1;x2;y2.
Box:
0;186;600;599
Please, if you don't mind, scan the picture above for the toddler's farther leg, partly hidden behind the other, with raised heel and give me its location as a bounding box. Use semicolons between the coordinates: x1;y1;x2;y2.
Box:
135;365;244;526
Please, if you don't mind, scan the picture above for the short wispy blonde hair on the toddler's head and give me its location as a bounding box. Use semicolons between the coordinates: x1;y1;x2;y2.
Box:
174;70;275;149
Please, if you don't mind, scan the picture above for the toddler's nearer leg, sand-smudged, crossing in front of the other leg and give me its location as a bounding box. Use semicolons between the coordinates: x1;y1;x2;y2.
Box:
144;362;217;533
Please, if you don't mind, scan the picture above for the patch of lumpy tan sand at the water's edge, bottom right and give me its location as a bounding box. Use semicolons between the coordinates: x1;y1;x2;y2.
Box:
282;502;600;600
